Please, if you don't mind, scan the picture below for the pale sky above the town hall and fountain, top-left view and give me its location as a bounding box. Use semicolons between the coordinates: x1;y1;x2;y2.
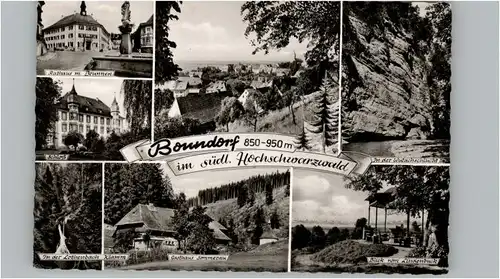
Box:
42;1;154;33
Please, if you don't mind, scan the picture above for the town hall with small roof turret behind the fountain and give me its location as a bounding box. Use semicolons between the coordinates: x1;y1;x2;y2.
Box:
43;1;112;51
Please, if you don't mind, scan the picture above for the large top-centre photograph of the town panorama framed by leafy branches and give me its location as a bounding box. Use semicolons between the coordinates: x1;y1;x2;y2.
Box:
154;1;340;154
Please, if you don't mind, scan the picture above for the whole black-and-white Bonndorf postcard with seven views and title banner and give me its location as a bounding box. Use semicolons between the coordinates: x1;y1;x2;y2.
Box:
33;1;452;274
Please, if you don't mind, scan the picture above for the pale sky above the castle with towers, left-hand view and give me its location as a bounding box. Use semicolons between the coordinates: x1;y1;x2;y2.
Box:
55;78;126;117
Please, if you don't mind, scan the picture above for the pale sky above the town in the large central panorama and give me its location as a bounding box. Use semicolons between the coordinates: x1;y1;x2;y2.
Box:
169;1;307;61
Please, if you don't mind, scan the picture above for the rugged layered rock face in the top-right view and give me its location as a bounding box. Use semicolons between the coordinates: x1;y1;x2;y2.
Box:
342;16;432;142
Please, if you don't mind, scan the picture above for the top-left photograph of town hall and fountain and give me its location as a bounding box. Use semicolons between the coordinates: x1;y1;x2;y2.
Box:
37;1;154;79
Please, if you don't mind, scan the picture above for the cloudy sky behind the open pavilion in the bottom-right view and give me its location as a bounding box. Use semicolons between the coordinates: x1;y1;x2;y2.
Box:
292;169;421;229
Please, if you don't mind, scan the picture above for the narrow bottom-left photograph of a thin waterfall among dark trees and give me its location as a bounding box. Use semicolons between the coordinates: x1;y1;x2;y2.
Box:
33;163;102;270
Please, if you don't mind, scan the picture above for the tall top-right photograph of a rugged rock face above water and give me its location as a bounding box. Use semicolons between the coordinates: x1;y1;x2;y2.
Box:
341;1;452;162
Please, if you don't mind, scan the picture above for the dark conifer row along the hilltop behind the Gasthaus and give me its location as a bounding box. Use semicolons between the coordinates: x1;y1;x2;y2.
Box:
188;171;290;206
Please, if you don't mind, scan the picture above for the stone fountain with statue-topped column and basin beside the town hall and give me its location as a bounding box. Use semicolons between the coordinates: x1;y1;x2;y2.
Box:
92;1;153;78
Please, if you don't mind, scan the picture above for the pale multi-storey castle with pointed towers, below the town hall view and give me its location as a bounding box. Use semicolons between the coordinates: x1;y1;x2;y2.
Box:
47;81;128;148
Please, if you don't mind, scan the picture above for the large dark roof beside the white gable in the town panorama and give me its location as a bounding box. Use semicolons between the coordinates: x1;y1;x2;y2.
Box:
176;94;229;123
